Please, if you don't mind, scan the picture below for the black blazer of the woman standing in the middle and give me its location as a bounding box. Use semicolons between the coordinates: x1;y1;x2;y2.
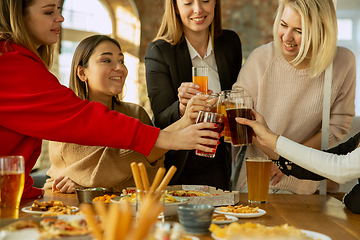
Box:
145;30;242;189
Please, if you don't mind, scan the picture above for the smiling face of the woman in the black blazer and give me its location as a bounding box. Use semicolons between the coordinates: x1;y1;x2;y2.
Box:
176;0;216;35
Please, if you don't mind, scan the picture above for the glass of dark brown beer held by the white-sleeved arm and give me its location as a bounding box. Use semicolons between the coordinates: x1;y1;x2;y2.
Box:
225;90;254;147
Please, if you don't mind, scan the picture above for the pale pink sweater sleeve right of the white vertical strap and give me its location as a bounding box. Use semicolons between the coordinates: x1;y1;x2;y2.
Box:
329;47;356;146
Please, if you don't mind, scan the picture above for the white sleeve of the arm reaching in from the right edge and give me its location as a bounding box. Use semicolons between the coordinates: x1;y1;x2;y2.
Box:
276;136;360;184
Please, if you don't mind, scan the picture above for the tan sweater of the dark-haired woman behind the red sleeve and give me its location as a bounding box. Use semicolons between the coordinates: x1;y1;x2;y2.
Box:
44;102;165;192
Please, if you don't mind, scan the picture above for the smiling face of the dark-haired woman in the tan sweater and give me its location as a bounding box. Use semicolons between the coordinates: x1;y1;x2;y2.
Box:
83;41;128;106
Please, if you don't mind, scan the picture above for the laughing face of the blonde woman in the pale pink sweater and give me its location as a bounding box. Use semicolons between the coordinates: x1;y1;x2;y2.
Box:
278;6;302;62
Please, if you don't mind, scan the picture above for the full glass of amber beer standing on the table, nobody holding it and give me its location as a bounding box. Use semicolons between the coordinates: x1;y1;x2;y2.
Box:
246;157;272;203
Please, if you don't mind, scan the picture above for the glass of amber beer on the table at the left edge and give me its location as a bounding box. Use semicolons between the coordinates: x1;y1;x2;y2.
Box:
0;156;25;219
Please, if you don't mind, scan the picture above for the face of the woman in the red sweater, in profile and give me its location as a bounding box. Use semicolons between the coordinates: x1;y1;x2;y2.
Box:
24;0;64;48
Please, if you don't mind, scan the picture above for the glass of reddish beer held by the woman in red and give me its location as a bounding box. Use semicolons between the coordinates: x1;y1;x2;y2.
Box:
195;111;224;158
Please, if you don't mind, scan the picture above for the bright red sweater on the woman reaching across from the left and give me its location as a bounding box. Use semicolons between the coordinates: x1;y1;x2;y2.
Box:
0;41;160;198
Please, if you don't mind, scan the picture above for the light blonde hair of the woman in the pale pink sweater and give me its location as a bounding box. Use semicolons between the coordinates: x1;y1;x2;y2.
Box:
273;0;337;77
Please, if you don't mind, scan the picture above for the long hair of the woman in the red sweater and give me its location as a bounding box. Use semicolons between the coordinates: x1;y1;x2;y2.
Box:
0;0;54;69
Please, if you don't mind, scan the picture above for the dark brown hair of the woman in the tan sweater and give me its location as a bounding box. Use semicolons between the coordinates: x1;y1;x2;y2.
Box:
69;35;121;102
